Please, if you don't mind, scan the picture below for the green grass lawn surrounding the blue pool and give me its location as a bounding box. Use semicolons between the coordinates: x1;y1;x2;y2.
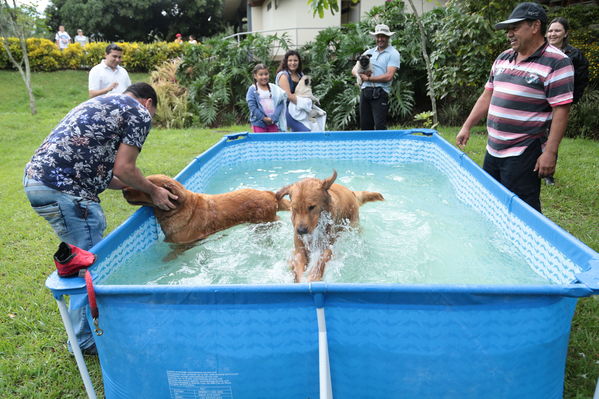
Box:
0;71;599;399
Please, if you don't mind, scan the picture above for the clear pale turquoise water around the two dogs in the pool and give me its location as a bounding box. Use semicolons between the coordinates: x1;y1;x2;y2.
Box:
102;160;551;285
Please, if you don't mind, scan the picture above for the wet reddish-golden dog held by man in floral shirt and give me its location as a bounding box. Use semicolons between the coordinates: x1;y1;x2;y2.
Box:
123;175;289;244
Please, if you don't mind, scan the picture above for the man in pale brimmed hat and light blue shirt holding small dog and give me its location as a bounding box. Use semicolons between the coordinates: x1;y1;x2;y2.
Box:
356;24;399;130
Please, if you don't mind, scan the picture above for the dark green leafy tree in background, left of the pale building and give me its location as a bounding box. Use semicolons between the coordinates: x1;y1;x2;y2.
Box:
46;0;225;41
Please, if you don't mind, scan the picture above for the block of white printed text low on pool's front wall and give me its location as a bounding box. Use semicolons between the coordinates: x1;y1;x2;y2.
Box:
166;370;239;399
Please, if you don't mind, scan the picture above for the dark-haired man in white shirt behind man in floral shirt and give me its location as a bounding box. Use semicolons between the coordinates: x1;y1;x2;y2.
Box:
88;43;131;98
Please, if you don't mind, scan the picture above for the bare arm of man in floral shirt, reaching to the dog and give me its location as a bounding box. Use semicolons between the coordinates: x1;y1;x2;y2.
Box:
110;143;177;211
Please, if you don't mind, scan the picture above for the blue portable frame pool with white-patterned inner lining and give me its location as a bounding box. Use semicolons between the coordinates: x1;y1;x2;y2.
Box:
46;130;599;399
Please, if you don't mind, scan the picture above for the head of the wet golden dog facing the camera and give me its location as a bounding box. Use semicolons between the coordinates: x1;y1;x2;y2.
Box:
277;170;337;235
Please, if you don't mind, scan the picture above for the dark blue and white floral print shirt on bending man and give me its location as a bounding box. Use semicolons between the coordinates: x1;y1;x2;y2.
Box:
25;94;152;202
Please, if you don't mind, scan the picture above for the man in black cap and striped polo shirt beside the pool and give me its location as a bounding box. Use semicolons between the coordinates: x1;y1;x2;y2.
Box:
456;2;574;212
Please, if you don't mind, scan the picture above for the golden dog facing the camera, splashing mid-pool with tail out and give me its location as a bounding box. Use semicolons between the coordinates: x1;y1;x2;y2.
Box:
277;171;384;282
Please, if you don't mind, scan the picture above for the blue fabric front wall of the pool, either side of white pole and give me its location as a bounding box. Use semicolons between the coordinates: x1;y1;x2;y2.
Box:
91;284;576;399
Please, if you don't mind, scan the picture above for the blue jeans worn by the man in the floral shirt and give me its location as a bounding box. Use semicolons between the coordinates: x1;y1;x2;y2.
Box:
23;176;106;349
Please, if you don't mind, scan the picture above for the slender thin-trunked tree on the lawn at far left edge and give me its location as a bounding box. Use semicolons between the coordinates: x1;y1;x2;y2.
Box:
0;0;37;115
